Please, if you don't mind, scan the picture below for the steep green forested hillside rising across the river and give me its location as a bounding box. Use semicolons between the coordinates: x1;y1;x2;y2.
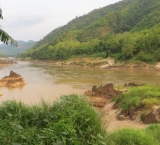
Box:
21;0;160;62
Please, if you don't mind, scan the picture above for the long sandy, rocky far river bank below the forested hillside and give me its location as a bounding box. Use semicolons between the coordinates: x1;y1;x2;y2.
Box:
20;57;160;71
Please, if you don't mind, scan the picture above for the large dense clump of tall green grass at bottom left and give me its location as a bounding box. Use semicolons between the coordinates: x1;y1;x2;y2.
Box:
0;95;106;145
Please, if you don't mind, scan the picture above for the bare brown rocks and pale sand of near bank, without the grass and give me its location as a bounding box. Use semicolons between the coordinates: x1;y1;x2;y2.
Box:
85;83;155;132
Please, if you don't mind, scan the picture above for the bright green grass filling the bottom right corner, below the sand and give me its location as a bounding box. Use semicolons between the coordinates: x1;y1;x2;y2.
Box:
107;125;160;145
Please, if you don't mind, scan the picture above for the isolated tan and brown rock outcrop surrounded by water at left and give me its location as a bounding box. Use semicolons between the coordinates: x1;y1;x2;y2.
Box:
0;71;26;88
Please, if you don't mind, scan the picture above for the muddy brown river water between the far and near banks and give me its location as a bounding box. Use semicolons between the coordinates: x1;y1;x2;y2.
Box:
0;62;160;104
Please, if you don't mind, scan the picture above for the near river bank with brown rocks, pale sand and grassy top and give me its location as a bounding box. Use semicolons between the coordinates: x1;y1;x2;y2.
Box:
85;83;160;132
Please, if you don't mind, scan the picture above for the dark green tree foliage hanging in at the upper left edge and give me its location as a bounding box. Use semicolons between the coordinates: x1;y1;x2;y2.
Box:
0;8;18;46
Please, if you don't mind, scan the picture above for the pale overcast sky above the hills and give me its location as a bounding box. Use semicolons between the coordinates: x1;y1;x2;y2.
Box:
0;0;120;41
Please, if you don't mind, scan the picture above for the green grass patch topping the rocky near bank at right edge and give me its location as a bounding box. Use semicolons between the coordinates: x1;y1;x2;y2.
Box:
113;85;160;110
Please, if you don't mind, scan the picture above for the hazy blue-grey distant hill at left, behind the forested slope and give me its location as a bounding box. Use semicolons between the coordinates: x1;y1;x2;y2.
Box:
0;40;36;56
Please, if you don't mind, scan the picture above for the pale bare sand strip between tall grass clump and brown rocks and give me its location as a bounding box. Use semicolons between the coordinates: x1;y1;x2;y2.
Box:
88;96;148;132
